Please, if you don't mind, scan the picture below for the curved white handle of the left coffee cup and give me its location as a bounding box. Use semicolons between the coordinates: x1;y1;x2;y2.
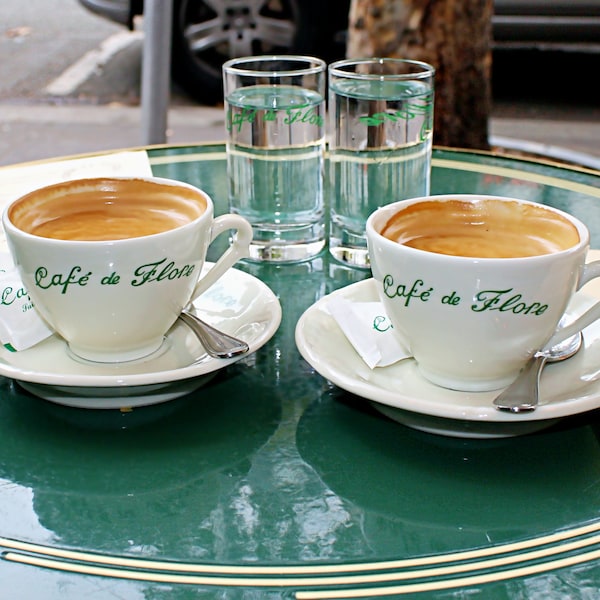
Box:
190;214;252;301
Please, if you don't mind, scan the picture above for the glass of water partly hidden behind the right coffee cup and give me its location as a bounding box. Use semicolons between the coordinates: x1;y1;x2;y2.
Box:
329;58;435;268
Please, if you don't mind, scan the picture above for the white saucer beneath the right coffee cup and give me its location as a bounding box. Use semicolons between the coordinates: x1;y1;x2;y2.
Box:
296;279;600;438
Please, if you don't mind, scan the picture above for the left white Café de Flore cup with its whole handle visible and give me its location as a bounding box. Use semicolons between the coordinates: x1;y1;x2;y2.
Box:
2;177;252;362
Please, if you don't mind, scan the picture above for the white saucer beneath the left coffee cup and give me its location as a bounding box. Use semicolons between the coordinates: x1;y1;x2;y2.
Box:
0;269;281;409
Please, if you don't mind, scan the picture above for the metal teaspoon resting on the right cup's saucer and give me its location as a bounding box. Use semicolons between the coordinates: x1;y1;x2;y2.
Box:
494;331;583;413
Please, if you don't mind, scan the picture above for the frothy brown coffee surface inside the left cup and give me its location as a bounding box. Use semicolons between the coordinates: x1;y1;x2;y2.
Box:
9;179;207;241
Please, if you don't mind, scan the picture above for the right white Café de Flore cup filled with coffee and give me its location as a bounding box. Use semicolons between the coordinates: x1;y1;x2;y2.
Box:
366;195;600;391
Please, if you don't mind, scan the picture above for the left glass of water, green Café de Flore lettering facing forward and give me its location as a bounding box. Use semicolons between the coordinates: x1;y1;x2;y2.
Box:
223;56;327;262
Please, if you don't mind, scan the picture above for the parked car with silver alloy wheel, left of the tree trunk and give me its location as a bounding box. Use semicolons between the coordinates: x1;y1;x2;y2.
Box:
79;0;349;104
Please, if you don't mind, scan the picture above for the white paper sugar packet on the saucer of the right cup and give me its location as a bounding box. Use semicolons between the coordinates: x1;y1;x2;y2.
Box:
327;296;411;369
